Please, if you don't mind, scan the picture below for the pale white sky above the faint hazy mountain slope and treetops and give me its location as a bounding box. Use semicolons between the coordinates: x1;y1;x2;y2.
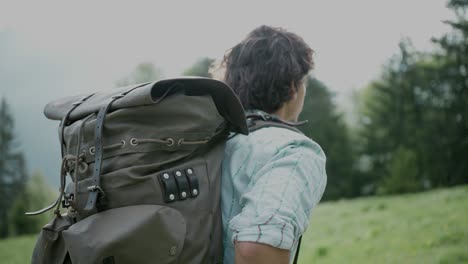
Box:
0;0;451;94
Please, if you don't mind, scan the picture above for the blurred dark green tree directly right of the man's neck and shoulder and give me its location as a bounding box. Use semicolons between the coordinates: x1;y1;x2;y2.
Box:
300;78;364;200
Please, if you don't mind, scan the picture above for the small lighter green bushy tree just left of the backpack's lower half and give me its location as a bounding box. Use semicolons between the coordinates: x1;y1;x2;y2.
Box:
8;172;56;235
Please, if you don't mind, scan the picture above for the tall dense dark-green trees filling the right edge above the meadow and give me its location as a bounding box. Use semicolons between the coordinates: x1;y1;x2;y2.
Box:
360;0;468;193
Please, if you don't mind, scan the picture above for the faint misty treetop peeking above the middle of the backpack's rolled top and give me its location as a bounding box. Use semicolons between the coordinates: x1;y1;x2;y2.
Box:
116;62;163;87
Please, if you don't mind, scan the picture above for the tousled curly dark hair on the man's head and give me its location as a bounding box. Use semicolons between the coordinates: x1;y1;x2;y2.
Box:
223;26;314;113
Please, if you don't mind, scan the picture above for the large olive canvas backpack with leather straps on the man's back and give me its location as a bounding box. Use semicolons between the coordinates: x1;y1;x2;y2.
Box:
28;78;249;264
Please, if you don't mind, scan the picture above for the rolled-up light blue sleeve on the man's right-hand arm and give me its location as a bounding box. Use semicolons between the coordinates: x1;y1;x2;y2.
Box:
229;139;326;250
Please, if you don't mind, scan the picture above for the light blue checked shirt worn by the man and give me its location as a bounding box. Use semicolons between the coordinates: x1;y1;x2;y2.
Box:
221;122;327;264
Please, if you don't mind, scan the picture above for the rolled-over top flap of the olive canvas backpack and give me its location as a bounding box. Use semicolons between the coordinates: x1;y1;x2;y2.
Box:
44;77;248;134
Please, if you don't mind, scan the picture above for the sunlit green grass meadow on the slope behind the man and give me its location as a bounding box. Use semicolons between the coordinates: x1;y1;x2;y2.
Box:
0;186;468;264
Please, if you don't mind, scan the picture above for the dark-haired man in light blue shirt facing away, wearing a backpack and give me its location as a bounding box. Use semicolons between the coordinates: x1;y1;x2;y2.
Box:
221;26;326;264
